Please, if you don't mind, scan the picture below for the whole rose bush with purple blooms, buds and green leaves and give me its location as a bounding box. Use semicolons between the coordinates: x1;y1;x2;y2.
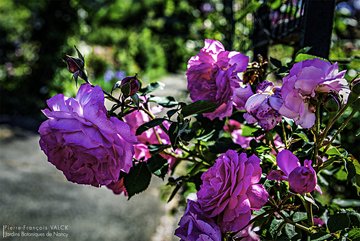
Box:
39;42;360;241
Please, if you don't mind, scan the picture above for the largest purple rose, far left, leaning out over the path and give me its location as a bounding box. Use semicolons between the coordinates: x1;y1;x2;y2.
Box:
39;84;136;186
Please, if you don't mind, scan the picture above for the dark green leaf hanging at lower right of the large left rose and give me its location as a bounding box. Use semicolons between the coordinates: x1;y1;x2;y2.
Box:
124;162;151;199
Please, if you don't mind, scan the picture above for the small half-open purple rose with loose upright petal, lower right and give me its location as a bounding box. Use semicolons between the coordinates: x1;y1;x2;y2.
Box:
268;150;319;194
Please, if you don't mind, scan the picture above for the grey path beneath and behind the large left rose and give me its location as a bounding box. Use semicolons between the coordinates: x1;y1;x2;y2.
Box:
0;75;185;241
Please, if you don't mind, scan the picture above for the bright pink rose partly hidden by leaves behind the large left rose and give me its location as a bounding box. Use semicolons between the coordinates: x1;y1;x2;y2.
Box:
124;108;181;170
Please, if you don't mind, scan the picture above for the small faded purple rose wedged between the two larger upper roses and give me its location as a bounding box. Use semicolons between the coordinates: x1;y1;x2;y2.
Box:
244;81;282;130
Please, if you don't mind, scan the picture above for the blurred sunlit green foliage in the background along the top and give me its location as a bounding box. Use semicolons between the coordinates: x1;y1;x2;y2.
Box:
0;0;360;137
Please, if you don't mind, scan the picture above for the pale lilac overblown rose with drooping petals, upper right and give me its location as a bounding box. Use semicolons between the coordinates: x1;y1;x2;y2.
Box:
278;59;349;128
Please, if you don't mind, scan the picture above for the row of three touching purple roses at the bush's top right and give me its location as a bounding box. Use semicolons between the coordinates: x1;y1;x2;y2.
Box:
186;39;349;130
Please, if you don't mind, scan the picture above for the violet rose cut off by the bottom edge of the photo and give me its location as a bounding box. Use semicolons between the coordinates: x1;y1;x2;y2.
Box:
175;200;222;241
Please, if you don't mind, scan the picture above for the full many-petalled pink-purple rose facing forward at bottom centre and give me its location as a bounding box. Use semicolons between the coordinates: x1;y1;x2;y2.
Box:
197;150;268;232
